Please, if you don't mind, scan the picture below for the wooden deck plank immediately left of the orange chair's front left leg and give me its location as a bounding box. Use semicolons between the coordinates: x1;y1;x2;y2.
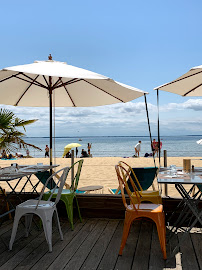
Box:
97;220;123;270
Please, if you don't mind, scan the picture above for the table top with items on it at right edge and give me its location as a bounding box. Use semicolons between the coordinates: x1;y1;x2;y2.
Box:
158;168;202;185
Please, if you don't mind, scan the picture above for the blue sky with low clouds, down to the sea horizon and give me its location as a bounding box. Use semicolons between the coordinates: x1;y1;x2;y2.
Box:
0;0;202;136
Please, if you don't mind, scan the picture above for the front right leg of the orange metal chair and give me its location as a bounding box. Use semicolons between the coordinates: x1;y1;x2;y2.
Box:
154;215;167;260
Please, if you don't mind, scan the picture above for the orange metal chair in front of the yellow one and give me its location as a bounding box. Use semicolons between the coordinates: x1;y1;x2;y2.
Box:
115;165;167;260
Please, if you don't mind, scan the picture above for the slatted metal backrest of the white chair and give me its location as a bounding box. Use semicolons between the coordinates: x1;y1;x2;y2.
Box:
36;167;70;209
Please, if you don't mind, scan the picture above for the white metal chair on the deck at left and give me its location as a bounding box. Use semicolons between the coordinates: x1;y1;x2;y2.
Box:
9;167;70;252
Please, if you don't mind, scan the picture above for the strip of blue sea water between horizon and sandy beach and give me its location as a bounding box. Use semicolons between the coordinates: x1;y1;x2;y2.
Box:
19;135;202;157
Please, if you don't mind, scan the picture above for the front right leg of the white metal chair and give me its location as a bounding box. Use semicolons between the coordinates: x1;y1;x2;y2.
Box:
41;212;53;252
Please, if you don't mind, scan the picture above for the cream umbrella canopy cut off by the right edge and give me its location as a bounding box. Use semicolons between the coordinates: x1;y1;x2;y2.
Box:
154;66;202;97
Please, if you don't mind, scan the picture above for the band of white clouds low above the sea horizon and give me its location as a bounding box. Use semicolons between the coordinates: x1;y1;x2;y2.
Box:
2;99;202;136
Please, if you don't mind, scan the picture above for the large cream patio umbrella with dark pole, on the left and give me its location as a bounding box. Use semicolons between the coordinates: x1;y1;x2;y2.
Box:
0;55;147;169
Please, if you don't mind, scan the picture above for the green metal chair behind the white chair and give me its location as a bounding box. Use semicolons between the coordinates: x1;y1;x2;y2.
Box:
43;159;84;230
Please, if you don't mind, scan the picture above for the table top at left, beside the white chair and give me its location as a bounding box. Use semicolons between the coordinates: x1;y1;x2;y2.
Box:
0;165;59;181
